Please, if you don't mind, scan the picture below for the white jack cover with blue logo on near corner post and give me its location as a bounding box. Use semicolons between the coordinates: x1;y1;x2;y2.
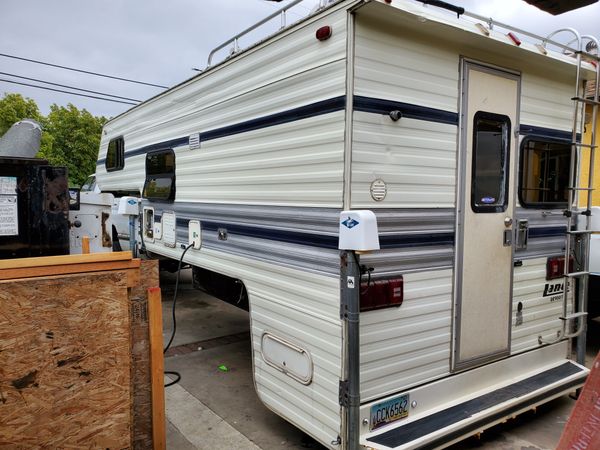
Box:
338;210;379;252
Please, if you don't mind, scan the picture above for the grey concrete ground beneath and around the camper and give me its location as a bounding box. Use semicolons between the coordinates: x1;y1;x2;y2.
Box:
161;270;600;450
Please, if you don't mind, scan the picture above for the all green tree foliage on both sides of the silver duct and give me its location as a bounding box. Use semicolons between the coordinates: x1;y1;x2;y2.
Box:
0;94;107;185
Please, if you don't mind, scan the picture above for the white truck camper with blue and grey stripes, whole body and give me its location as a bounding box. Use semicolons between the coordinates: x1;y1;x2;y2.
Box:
97;0;600;449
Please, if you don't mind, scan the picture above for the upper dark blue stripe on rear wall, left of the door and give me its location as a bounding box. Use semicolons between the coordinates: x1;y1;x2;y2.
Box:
354;95;458;125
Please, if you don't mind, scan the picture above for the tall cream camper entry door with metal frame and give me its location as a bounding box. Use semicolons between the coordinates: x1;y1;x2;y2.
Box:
453;61;519;370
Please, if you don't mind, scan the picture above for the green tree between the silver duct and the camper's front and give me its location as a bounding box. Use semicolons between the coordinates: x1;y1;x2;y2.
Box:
38;103;107;185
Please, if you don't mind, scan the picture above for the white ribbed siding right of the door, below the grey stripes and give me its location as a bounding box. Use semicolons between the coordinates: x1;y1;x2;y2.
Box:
511;258;562;354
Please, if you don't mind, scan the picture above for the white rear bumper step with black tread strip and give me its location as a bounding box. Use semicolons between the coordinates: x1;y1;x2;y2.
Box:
360;342;589;450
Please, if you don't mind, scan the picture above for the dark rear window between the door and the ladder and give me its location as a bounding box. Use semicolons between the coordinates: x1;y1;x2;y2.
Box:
519;137;571;208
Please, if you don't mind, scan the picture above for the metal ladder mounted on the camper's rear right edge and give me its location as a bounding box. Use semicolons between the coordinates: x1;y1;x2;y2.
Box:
538;28;600;364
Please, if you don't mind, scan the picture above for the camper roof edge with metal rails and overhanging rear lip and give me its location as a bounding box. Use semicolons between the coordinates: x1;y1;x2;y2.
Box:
107;0;600;124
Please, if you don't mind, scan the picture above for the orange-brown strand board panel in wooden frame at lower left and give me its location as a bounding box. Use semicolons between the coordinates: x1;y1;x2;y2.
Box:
0;272;132;449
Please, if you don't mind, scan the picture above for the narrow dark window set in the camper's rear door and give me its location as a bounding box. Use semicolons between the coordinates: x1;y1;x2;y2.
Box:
471;111;510;213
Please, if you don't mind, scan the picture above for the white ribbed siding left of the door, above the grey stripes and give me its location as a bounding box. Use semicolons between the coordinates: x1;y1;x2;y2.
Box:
351;14;459;208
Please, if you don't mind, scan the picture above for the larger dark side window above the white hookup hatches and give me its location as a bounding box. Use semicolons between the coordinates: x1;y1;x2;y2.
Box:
142;149;175;201
